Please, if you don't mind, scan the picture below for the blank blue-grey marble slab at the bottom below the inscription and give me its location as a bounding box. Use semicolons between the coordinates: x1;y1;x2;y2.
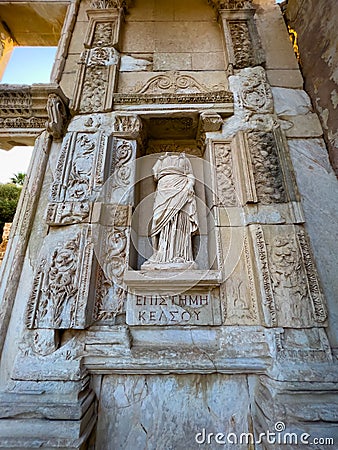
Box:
96;374;250;450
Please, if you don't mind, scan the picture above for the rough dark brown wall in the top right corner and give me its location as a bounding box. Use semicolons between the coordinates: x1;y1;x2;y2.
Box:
286;0;338;178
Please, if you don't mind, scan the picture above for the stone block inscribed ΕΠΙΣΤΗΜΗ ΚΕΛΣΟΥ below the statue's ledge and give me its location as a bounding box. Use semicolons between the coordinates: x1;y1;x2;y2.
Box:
126;291;221;326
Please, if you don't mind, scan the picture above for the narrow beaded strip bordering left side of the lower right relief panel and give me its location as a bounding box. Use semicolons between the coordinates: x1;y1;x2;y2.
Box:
256;226;277;326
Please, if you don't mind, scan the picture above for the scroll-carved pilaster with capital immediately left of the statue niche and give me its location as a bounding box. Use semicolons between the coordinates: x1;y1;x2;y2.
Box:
94;113;143;324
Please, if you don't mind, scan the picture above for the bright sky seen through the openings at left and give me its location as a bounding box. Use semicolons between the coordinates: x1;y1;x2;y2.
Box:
0;47;56;183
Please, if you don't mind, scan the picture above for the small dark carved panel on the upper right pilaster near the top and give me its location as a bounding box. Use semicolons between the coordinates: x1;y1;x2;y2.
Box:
228;20;255;69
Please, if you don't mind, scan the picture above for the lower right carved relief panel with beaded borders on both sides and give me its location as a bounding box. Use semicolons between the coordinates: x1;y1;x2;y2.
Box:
255;225;326;328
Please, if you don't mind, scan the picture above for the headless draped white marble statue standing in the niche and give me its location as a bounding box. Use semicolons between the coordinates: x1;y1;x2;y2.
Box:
141;153;198;269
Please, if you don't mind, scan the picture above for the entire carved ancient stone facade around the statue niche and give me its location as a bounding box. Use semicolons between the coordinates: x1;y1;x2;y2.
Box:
0;0;338;450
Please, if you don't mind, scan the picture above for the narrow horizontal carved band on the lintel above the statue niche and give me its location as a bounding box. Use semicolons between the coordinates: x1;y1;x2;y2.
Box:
113;91;233;105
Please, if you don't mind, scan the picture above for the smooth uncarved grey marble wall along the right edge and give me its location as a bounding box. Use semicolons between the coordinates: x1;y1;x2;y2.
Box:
289;139;338;347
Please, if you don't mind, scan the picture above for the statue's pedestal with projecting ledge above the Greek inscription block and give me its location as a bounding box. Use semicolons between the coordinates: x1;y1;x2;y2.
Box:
125;270;221;326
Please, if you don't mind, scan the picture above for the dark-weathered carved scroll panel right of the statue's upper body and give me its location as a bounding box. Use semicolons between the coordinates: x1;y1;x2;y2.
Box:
248;131;287;204
